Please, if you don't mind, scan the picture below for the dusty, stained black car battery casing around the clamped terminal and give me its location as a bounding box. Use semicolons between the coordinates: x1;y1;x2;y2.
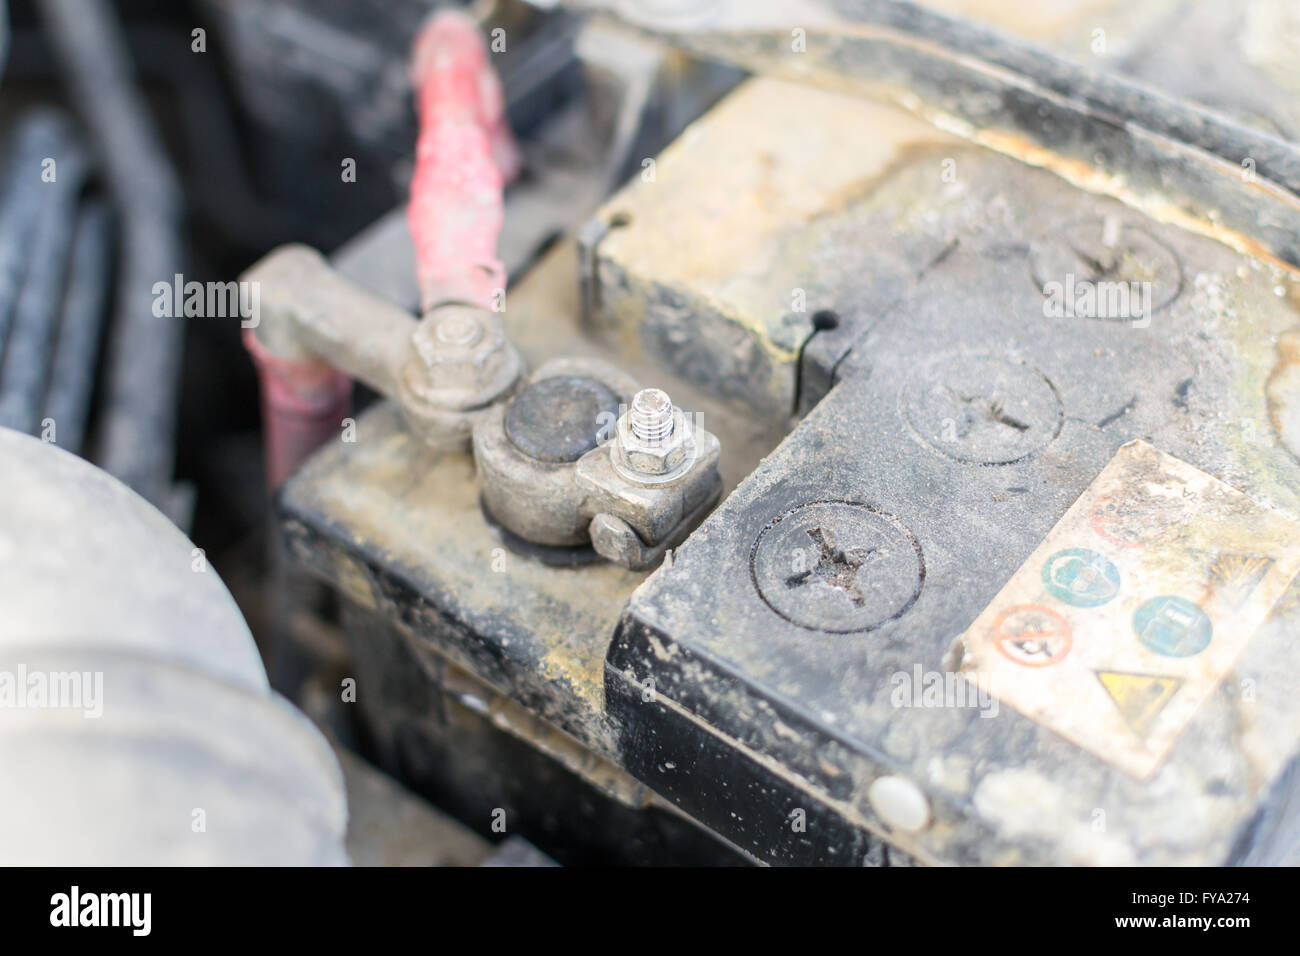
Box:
281;79;1300;865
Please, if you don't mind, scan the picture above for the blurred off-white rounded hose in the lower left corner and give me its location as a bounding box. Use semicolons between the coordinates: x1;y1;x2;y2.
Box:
0;424;347;865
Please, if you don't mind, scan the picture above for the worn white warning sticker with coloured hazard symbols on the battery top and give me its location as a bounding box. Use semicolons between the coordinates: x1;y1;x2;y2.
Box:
959;441;1300;778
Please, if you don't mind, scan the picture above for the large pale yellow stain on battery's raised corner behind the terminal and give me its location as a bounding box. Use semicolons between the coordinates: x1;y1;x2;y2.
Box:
601;77;956;363
